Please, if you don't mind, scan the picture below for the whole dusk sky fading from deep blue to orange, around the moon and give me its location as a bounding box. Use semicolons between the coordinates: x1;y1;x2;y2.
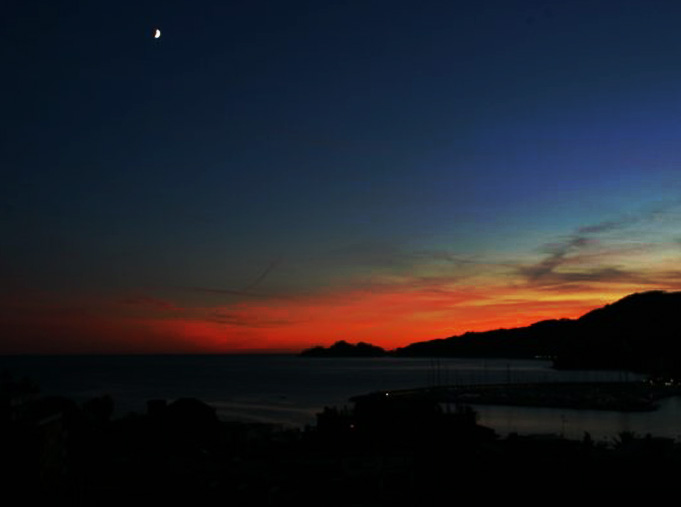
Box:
0;0;681;353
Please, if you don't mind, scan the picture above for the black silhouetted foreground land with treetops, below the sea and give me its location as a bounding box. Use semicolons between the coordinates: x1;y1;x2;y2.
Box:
0;379;681;507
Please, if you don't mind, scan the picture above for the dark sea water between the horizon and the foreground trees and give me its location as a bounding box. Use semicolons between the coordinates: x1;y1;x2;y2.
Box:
0;355;681;440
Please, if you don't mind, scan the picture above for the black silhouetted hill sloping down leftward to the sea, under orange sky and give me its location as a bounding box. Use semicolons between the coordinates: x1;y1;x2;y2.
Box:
395;291;681;374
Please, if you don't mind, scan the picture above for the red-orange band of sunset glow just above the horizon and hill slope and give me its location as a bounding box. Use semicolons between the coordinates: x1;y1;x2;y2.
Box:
0;286;668;353
